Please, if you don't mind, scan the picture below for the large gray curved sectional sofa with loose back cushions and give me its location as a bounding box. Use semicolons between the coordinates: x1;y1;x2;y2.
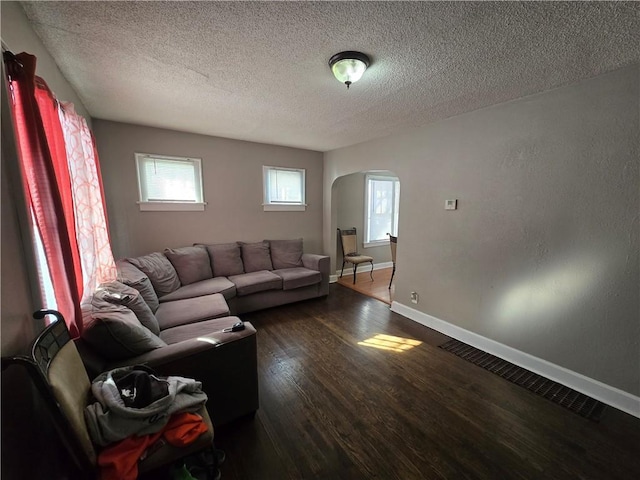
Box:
77;239;329;425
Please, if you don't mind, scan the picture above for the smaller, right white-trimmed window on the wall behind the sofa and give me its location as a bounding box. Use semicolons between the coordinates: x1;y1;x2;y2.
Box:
262;166;307;212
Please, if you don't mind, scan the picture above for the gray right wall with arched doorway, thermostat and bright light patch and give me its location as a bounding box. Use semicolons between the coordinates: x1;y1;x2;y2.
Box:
324;65;640;395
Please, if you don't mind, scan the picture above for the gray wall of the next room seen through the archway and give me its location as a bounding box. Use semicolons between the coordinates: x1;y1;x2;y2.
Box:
333;172;391;274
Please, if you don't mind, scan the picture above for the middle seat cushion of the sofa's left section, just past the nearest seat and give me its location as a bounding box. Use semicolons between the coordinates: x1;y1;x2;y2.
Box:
156;293;229;331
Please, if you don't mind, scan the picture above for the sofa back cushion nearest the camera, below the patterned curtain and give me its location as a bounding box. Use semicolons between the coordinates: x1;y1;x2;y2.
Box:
82;298;166;360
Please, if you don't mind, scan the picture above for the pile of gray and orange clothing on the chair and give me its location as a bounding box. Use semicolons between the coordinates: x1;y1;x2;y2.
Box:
84;365;212;480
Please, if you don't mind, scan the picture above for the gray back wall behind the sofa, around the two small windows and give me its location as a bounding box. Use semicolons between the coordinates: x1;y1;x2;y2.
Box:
94;119;323;258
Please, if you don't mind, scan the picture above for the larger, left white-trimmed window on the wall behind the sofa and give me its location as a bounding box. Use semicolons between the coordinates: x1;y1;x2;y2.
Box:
136;153;206;211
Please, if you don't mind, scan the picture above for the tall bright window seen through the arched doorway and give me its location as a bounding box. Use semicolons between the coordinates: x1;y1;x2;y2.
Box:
364;175;400;247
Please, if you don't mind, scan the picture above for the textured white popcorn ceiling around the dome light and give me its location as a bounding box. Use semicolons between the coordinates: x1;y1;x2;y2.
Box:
17;1;640;151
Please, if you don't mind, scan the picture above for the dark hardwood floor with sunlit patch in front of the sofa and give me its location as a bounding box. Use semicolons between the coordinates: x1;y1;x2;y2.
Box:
216;284;640;480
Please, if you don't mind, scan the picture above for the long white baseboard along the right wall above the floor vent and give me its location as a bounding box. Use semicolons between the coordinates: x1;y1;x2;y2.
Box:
391;302;640;418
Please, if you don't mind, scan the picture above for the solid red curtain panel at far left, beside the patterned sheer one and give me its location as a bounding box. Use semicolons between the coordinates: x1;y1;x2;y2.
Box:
5;53;82;337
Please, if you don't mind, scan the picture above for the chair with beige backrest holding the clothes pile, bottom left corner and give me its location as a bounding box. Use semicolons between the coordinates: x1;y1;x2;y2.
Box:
2;310;217;478
